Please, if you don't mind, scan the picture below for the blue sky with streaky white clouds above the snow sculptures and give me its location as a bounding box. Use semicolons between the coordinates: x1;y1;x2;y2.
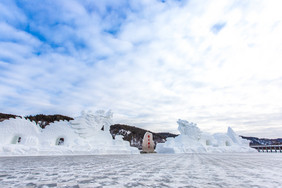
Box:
0;0;282;138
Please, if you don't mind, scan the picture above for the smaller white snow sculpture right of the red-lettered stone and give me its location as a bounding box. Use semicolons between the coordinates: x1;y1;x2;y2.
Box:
156;119;256;153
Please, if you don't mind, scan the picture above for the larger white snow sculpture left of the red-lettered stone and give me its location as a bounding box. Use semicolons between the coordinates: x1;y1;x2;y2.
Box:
0;110;139;156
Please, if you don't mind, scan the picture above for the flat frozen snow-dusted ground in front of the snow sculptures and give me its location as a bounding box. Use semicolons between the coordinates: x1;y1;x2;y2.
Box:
0;153;282;188
